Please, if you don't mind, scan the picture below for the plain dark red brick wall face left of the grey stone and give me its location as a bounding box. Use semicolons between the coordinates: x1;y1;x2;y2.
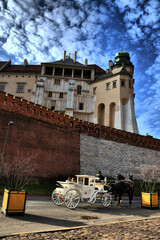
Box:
0;109;80;179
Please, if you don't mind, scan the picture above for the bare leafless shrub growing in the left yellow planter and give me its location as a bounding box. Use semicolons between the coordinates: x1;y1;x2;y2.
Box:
3;150;37;191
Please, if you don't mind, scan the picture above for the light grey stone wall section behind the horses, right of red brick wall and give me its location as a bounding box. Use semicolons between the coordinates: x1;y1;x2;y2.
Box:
80;134;160;179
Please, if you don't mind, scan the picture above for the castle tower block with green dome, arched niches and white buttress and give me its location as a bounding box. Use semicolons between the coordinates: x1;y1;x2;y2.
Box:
90;50;138;133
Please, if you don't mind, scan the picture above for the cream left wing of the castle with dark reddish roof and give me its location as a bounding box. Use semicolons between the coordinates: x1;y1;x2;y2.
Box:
0;59;41;101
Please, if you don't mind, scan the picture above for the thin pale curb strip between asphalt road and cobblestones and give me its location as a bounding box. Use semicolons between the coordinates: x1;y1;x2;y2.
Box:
0;216;160;239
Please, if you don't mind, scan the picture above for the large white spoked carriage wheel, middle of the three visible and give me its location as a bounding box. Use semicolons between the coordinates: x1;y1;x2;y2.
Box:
64;189;80;209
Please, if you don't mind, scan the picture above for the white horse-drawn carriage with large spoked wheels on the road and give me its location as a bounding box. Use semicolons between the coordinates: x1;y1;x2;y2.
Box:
52;175;112;209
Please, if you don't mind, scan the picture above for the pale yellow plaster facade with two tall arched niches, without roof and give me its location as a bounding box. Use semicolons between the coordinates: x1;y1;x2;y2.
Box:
90;74;134;130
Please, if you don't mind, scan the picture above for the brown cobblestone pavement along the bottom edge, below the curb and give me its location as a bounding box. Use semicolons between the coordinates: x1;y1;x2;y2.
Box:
2;218;160;240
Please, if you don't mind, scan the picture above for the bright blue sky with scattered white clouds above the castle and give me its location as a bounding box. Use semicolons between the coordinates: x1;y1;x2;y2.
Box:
0;0;160;139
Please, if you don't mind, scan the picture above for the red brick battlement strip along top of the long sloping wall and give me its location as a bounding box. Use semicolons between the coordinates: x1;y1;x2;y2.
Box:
0;92;160;151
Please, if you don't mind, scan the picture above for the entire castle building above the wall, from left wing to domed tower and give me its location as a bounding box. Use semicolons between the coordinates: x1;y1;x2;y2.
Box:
0;51;138;133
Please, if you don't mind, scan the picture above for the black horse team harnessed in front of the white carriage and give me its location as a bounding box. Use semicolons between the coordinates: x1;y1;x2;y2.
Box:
109;173;134;204
